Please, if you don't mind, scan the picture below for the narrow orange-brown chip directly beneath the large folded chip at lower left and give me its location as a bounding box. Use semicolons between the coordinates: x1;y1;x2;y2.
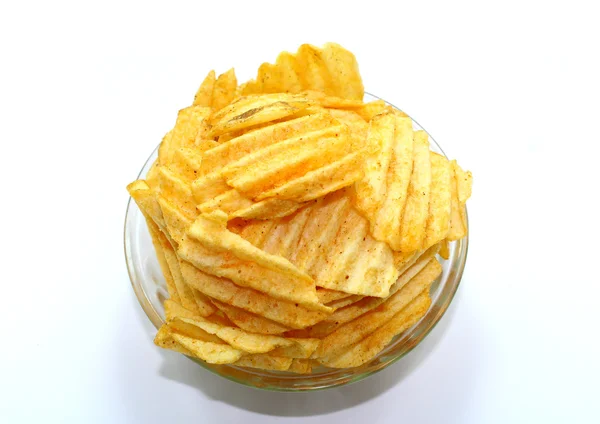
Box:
181;262;329;329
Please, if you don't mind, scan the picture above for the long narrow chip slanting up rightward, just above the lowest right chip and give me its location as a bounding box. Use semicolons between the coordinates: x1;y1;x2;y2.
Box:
316;261;442;365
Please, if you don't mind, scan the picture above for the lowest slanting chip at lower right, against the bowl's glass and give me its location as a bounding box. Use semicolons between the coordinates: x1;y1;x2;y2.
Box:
320;291;431;368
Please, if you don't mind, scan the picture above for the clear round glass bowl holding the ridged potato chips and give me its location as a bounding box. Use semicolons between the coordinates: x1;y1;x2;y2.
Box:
124;94;469;391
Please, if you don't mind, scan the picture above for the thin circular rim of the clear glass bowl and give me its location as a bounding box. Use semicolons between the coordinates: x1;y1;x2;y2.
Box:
123;92;469;392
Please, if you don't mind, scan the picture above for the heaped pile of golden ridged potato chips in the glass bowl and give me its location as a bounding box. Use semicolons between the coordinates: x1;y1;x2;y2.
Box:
127;43;471;373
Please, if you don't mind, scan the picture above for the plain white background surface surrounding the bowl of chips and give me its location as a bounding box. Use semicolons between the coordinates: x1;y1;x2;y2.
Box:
0;0;600;424
